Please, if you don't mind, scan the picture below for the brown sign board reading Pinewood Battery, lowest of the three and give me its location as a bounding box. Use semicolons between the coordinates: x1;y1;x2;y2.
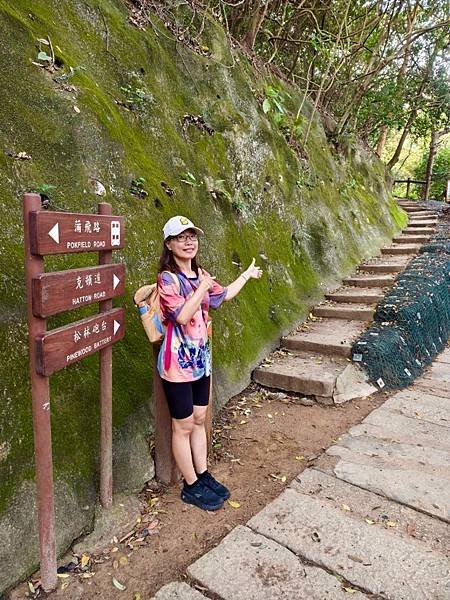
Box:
36;308;125;377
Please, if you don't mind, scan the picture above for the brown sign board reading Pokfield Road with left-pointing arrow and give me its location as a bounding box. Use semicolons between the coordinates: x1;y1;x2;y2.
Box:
30;210;125;256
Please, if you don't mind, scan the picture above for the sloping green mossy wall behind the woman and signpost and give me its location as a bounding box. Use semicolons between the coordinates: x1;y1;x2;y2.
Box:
0;0;405;590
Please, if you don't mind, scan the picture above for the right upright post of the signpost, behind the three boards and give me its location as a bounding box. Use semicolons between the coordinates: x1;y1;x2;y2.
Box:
98;202;113;508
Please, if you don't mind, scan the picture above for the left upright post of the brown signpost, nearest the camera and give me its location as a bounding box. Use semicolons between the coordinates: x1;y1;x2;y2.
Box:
23;194;58;592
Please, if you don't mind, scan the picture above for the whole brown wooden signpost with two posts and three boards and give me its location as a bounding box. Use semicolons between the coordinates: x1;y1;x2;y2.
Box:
23;194;125;591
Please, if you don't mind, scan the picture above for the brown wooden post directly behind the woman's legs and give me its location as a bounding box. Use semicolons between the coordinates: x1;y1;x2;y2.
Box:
153;344;180;485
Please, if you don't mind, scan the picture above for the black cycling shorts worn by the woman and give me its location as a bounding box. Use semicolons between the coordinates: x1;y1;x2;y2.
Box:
162;376;210;419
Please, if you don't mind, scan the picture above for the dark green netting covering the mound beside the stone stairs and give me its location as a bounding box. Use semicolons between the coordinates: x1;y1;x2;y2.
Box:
352;218;450;389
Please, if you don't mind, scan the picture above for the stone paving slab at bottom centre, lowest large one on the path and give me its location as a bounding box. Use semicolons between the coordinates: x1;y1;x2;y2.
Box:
187;524;370;600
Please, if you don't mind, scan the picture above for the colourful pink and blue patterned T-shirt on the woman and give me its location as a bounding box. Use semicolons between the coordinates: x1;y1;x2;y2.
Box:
158;271;227;382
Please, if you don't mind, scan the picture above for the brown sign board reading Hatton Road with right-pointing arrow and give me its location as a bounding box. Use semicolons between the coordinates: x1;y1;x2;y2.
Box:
33;264;125;318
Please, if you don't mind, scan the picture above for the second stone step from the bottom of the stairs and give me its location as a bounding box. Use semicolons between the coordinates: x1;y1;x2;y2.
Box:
281;319;367;358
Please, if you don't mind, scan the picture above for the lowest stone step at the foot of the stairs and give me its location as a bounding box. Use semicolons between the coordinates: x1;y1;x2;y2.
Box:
253;352;348;398
